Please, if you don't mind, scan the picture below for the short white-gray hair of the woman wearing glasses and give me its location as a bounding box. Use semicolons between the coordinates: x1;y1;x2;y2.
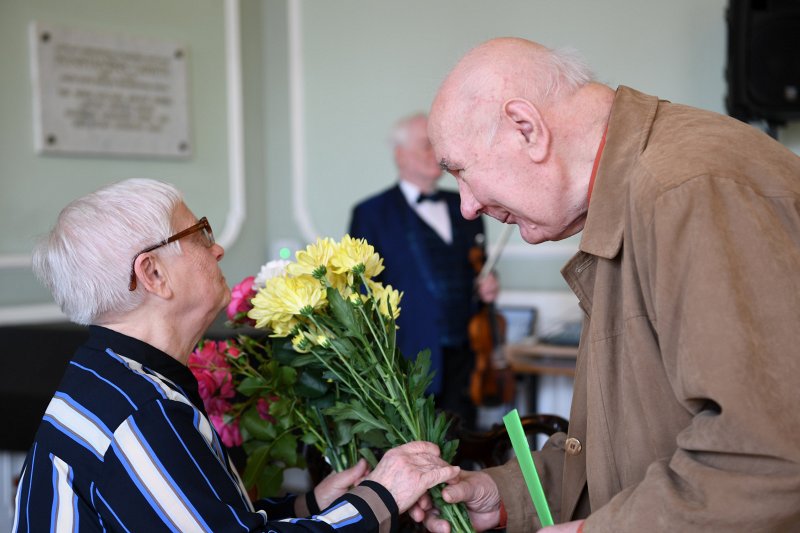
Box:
33;179;183;324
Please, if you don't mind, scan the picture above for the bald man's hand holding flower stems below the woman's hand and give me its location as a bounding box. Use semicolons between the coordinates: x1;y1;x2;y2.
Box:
409;470;500;533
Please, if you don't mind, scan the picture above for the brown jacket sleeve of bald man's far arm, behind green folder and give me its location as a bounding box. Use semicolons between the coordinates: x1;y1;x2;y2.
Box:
484;433;567;533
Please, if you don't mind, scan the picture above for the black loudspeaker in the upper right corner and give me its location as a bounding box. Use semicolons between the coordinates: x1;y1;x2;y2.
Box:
725;0;800;125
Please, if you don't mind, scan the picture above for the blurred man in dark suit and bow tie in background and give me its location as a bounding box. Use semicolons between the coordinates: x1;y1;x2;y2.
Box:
350;114;498;429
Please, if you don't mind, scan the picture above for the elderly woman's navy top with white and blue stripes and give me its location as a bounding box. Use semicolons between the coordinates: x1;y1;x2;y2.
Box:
13;326;397;533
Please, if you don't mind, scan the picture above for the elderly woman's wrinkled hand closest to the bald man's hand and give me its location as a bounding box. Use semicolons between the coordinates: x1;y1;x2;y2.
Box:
367;441;461;513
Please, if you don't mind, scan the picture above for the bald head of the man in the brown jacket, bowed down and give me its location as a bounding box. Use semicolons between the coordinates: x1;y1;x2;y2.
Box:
428;38;614;243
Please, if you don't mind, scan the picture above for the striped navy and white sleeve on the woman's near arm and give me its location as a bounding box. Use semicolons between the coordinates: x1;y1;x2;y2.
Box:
94;400;397;532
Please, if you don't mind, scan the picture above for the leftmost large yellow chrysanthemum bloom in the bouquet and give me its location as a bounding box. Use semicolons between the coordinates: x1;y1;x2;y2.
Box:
247;275;327;337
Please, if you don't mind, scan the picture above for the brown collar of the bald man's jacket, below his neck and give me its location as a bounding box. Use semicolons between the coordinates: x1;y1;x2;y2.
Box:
580;85;658;259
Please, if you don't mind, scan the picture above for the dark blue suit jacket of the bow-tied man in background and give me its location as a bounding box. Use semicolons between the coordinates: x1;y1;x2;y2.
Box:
350;185;484;393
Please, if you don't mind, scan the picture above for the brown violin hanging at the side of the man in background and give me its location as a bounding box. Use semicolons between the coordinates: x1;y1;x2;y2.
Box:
468;231;515;406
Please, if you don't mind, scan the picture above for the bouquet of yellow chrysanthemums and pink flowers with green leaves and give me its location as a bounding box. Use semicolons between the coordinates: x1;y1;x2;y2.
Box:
190;236;472;531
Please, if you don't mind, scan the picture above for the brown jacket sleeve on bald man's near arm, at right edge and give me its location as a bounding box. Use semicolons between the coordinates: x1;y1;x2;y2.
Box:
584;176;800;533
